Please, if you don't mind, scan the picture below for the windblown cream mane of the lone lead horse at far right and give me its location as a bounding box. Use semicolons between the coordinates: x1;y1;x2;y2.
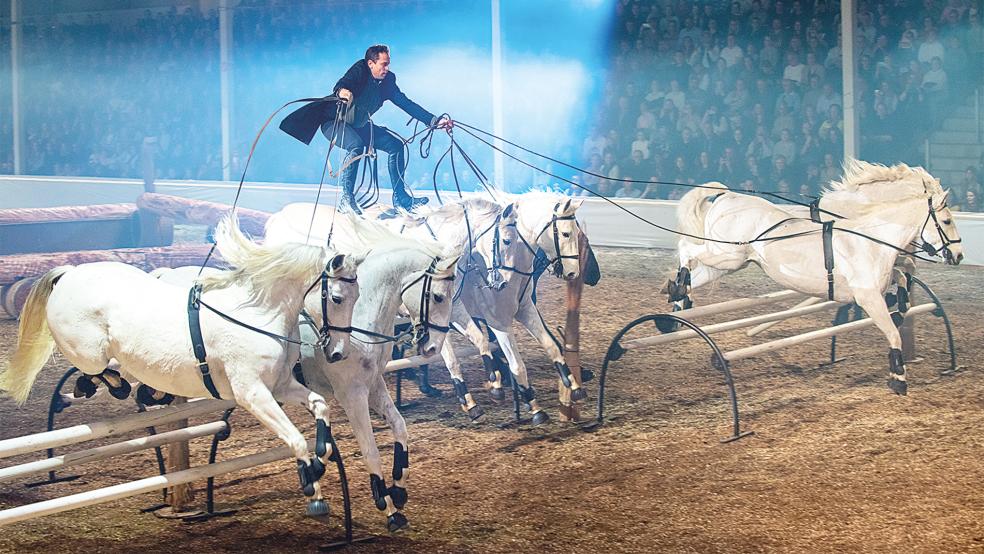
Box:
821;160;943;208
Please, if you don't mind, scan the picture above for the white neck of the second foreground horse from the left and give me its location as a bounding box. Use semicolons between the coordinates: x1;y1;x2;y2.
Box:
352;249;431;334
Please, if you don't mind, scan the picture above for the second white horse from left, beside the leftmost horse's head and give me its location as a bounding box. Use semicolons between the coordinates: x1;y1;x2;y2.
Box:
266;204;459;531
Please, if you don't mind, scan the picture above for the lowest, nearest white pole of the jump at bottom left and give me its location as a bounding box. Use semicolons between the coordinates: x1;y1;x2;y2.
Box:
0;441;314;527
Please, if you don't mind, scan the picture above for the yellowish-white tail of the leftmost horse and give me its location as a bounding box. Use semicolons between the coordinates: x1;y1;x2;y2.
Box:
0;265;72;404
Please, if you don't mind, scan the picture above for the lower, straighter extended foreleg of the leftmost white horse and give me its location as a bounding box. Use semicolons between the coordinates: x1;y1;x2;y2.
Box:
226;380;327;515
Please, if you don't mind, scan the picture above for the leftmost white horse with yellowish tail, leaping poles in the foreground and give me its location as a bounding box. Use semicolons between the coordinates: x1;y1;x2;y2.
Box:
0;215;362;515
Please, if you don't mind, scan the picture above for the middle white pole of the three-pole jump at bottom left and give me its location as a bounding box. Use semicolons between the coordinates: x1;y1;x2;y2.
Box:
0;421;227;483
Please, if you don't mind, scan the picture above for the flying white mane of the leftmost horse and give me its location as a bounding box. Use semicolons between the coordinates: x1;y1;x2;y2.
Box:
201;214;330;302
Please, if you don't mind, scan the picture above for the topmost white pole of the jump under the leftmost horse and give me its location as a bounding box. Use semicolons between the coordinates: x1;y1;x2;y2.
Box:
0;400;236;458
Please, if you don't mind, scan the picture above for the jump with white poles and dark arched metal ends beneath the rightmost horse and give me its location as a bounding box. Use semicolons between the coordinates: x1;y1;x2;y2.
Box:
595;277;957;442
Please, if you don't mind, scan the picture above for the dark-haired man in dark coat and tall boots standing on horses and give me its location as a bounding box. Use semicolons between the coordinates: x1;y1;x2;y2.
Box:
321;44;453;214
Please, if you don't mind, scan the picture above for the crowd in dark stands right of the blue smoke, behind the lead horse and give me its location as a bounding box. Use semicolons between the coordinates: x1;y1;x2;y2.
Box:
581;0;984;208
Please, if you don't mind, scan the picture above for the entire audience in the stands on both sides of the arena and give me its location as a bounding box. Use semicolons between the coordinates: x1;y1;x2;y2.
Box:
0;0;984;210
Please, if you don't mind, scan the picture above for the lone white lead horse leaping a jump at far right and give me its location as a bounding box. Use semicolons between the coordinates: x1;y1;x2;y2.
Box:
668;161;963;394
